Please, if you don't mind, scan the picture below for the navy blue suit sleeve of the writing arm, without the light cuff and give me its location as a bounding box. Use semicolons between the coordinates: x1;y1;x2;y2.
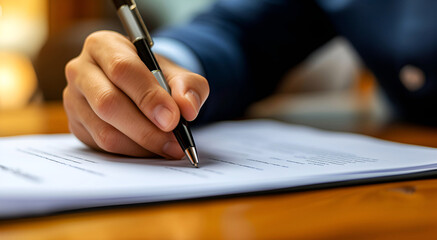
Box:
156;0;336;122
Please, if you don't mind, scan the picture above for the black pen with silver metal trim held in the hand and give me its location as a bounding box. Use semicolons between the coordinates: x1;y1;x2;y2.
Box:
113;0;199;167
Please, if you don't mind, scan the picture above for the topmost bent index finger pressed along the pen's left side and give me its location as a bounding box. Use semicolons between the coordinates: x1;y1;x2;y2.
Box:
85;31;180;132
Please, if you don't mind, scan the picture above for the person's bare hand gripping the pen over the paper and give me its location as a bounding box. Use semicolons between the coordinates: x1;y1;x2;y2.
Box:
63;31;209;159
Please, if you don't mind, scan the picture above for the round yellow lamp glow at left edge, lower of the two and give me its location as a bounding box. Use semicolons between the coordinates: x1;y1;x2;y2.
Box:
0;52;37;109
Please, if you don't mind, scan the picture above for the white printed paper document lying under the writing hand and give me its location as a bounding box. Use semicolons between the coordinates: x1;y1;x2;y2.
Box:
0;120;437;218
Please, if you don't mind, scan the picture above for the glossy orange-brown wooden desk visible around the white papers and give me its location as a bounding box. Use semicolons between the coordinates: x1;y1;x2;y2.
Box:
0;104;437;240
